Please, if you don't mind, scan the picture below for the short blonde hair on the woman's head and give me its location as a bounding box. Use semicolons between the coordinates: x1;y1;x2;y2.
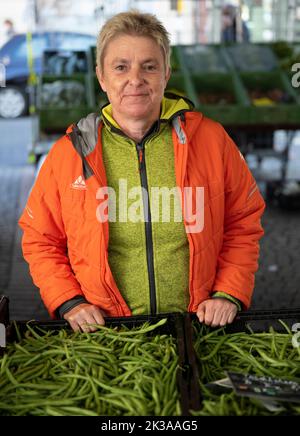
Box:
96;10;171;70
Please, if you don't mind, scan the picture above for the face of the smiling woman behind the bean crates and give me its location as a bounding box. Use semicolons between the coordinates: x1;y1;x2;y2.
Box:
96;35;170;121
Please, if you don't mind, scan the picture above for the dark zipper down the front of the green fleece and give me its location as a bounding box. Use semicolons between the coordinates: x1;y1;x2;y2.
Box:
136;142;157;315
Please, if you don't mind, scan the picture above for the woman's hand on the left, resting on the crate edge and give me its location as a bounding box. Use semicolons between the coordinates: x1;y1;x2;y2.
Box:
63;303;105;332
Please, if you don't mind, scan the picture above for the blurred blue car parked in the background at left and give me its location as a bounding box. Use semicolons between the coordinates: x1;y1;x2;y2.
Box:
0;32;96;118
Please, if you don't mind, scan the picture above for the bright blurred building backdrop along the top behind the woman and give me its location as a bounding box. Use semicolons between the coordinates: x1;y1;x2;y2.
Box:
0;0;300;45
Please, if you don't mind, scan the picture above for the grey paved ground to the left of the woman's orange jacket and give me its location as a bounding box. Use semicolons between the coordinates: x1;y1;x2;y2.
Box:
0;117;48;320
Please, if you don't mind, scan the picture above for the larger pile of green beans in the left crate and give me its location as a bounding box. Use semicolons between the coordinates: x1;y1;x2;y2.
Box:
0;319;181;416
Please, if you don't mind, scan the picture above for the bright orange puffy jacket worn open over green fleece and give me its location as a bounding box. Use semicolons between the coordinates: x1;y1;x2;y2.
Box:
19;112;265;317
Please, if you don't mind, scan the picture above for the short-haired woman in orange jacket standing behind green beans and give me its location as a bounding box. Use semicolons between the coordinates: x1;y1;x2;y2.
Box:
20;11;264;331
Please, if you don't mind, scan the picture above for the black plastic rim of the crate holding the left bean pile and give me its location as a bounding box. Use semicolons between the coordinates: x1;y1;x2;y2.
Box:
2;313;190;416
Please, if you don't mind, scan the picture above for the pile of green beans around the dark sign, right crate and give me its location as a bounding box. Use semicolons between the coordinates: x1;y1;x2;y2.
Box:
192;323;300;416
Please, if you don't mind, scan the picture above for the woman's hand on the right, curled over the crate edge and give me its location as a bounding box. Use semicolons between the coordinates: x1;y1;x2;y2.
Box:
197;298;238;327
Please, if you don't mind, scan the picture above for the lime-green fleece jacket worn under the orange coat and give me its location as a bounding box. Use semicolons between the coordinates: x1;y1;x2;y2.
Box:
102;98;190;315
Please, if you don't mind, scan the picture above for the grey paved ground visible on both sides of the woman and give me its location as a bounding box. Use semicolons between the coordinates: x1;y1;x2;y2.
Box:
0;117;300;320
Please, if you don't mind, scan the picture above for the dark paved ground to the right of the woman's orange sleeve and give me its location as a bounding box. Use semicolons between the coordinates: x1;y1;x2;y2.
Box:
252;201;300;309
